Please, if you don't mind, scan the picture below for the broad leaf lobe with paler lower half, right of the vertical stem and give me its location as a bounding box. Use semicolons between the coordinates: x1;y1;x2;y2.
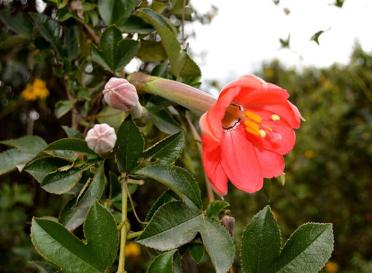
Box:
138;201;200;251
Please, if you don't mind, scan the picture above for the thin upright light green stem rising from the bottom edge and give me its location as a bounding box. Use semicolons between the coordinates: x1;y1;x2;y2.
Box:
117;178;128;273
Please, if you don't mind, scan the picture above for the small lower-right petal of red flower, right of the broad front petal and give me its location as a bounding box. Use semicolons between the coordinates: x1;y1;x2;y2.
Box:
255;147;285;178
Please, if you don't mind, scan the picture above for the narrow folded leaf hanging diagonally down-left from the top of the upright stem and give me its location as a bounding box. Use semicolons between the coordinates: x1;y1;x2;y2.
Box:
60;163;107;230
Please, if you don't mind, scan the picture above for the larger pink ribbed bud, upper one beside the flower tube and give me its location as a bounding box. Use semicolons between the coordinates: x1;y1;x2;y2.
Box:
103;78;139;112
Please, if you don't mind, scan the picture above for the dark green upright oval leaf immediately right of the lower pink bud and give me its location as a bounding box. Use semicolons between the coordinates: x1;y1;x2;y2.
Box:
115;118;144;172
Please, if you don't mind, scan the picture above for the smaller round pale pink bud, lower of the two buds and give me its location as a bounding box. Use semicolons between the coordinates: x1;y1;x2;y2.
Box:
85;123;116;155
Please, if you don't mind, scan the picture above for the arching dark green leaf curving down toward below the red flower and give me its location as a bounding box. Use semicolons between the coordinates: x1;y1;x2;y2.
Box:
136;165;202;208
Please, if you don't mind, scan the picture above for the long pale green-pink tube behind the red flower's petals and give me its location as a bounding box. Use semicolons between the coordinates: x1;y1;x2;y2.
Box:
127;72;216;114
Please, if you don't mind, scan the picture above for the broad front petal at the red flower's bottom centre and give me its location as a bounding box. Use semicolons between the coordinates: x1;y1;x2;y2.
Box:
222;126;263;193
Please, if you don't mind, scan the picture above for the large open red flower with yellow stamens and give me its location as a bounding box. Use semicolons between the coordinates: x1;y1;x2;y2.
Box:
200;76;301;195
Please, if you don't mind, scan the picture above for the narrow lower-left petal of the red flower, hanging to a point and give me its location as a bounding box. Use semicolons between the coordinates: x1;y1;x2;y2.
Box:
202;137;227;195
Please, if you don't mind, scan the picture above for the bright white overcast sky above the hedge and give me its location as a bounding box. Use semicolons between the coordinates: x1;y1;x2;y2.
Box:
189;0;372;82
